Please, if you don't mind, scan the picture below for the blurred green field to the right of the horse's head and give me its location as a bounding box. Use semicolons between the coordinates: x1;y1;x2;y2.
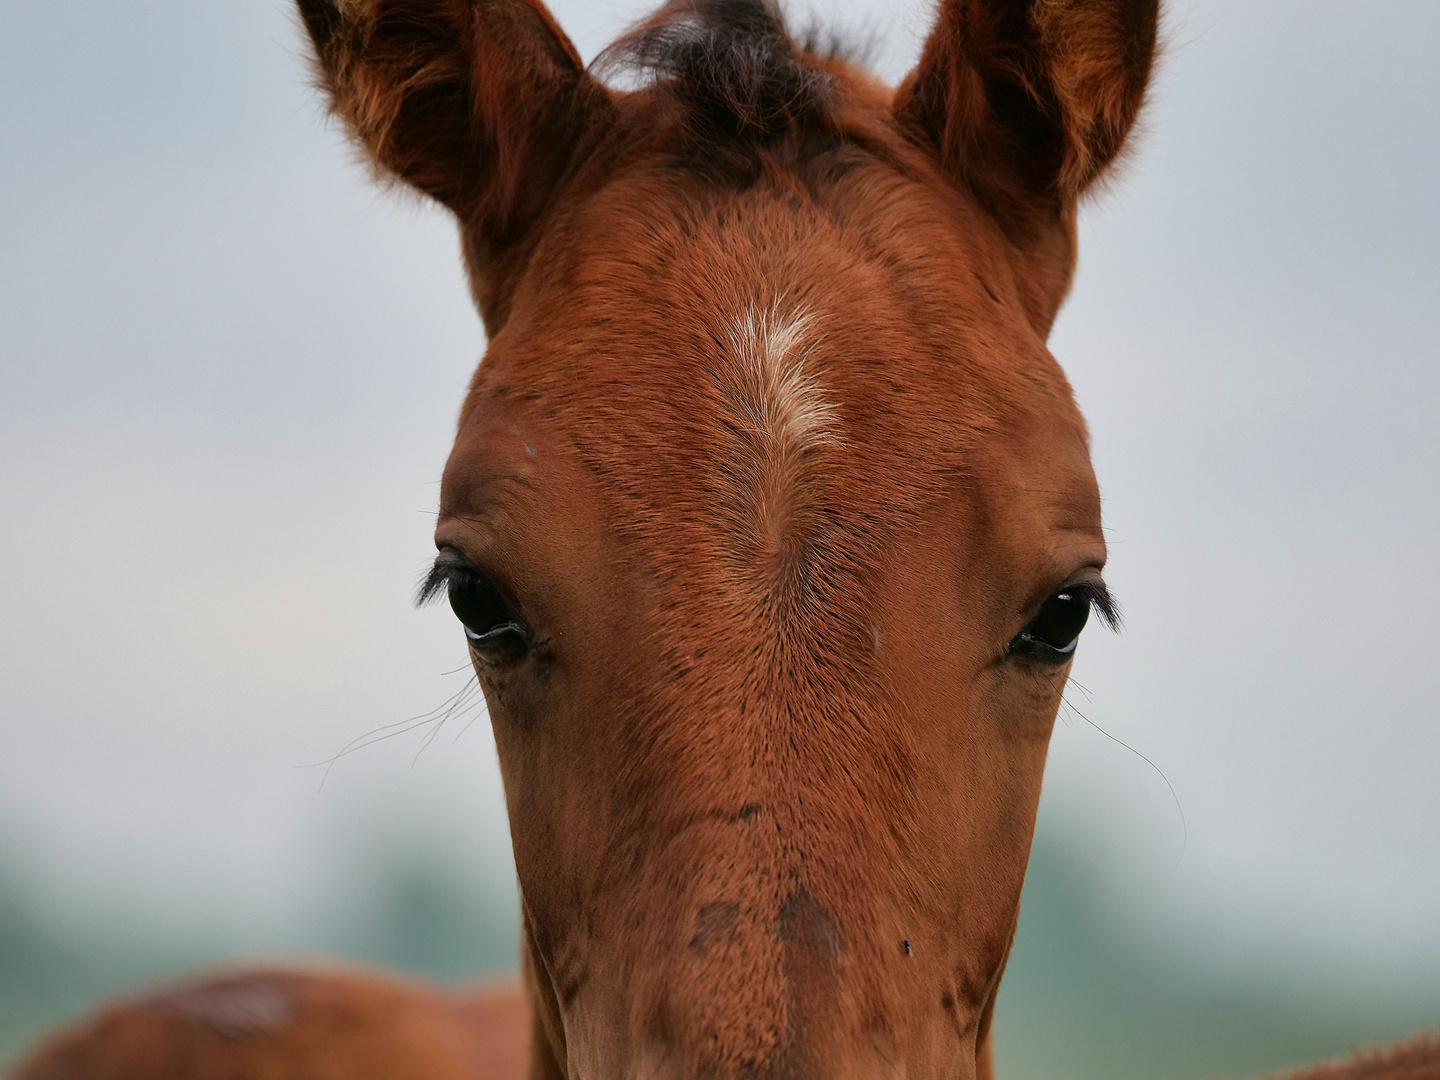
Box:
996;835;1440;1080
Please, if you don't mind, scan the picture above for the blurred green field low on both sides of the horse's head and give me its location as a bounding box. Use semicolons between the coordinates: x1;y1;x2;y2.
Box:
0;837;1440;1080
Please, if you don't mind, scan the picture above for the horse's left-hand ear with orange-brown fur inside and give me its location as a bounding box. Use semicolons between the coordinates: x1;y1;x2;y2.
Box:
298;0;608;318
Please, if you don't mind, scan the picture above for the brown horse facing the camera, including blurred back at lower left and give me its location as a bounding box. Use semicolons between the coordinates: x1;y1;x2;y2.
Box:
5;0;1440;1080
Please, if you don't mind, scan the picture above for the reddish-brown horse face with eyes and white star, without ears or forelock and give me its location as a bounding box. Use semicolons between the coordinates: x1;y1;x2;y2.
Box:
436;188;1104;1076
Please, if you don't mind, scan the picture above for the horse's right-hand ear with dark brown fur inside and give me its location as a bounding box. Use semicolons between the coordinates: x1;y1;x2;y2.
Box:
896;0;1159;243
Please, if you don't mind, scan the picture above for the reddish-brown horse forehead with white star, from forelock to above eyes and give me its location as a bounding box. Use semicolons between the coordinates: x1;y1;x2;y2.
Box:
462;180;1086;544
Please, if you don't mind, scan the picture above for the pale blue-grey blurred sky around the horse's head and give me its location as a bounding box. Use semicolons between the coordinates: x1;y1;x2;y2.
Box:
0;0;1440;985
